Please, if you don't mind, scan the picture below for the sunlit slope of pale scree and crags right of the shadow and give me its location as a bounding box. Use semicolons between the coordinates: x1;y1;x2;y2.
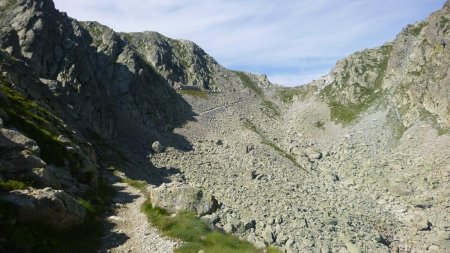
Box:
152;2;450;252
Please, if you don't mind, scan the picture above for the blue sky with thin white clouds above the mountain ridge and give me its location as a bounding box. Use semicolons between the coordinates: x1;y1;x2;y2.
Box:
54;0;445;86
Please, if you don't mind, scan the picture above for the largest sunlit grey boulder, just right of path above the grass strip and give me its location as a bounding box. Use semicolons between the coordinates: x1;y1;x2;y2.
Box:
150;184;219;216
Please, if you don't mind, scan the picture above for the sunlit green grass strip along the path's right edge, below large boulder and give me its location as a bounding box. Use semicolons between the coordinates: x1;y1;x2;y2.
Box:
142;201;280;253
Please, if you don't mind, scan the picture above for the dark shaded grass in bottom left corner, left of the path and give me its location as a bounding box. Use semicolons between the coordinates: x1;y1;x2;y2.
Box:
0;181;115;253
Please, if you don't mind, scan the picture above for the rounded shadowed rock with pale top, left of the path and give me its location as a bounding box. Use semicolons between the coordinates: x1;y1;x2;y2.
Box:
0;188;86;229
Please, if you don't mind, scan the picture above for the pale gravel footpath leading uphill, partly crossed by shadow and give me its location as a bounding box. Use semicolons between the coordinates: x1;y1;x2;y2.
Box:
99;178;176;253
